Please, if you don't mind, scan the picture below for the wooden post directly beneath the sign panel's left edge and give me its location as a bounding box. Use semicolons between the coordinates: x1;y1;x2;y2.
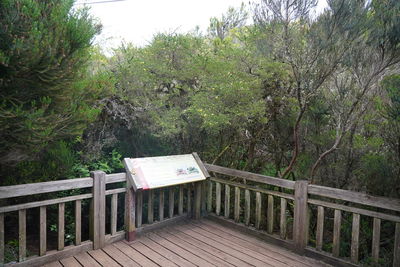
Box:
125;181;136;242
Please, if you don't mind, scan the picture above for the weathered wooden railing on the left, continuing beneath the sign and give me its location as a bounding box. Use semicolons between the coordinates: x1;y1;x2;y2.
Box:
0;171;204;266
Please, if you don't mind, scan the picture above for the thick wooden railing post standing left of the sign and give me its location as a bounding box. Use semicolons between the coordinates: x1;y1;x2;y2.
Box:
90;171;106;249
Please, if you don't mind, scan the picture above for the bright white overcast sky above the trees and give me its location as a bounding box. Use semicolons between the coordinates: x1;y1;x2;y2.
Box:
76;0;326;52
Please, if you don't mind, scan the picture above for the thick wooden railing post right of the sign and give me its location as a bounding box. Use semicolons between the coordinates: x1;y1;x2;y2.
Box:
293;180;308;254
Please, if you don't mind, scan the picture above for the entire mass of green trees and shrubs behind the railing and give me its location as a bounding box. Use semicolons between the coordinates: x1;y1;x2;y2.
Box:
0;0;400;265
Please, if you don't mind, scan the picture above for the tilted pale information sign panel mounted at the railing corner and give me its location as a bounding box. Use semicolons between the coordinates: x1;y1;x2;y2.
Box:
124;153;208;190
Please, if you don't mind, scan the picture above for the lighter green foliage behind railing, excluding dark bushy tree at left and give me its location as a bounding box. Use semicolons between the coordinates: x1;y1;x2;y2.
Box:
76;1;400;197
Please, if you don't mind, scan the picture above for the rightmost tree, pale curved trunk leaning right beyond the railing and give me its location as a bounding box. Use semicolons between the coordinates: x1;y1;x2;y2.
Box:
310;1;400;181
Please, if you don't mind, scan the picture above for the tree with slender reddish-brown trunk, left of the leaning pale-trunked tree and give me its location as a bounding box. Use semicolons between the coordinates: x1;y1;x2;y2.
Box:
255;0;354;180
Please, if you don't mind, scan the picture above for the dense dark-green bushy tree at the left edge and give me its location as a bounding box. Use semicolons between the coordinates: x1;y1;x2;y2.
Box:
0;0;101;165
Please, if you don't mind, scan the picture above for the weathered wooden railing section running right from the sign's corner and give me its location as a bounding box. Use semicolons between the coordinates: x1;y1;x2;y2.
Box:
205;164;400;266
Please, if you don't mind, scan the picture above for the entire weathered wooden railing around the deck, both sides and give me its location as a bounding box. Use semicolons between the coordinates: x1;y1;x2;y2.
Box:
0;164;400;266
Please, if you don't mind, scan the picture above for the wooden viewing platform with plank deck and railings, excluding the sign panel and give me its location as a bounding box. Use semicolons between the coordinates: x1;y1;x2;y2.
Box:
0;164;400;267
